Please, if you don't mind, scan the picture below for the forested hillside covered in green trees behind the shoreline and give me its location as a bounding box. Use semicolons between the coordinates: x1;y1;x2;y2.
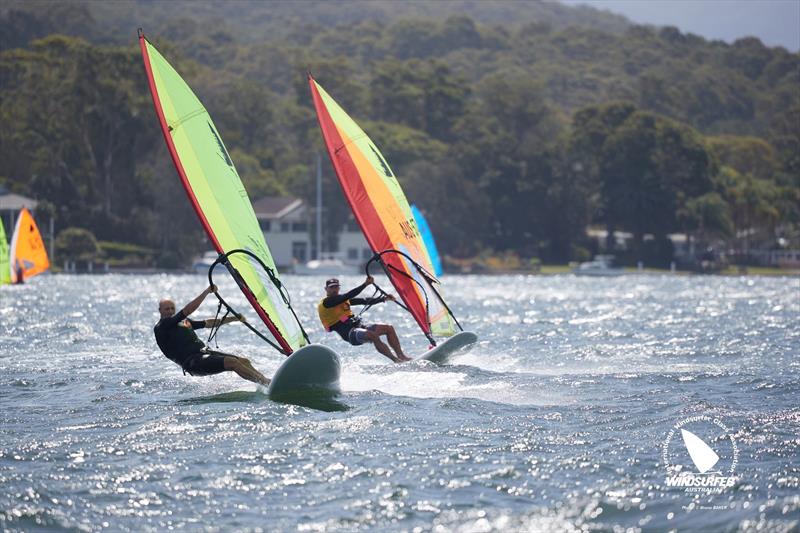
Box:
0;1;800;264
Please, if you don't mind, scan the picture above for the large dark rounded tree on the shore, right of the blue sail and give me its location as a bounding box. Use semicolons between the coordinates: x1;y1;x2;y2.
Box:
572;104;716;258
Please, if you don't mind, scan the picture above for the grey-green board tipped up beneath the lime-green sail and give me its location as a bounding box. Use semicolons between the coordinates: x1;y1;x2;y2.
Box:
267;344;342;400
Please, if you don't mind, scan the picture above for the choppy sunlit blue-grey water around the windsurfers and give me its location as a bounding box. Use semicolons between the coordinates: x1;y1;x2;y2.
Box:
0;275;800;532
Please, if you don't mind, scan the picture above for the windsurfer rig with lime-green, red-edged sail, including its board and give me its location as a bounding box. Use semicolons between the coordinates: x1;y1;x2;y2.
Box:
139;29;340;399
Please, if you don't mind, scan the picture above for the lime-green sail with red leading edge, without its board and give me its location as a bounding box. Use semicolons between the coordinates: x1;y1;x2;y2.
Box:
139;35;307;355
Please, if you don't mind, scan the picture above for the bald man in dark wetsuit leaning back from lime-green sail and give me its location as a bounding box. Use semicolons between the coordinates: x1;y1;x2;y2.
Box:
153;285;270;385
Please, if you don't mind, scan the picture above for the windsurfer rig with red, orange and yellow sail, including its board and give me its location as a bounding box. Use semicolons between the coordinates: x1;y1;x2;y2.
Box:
308;75;478;361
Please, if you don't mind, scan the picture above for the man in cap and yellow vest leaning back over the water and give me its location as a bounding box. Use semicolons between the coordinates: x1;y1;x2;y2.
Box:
317;276;411;363
